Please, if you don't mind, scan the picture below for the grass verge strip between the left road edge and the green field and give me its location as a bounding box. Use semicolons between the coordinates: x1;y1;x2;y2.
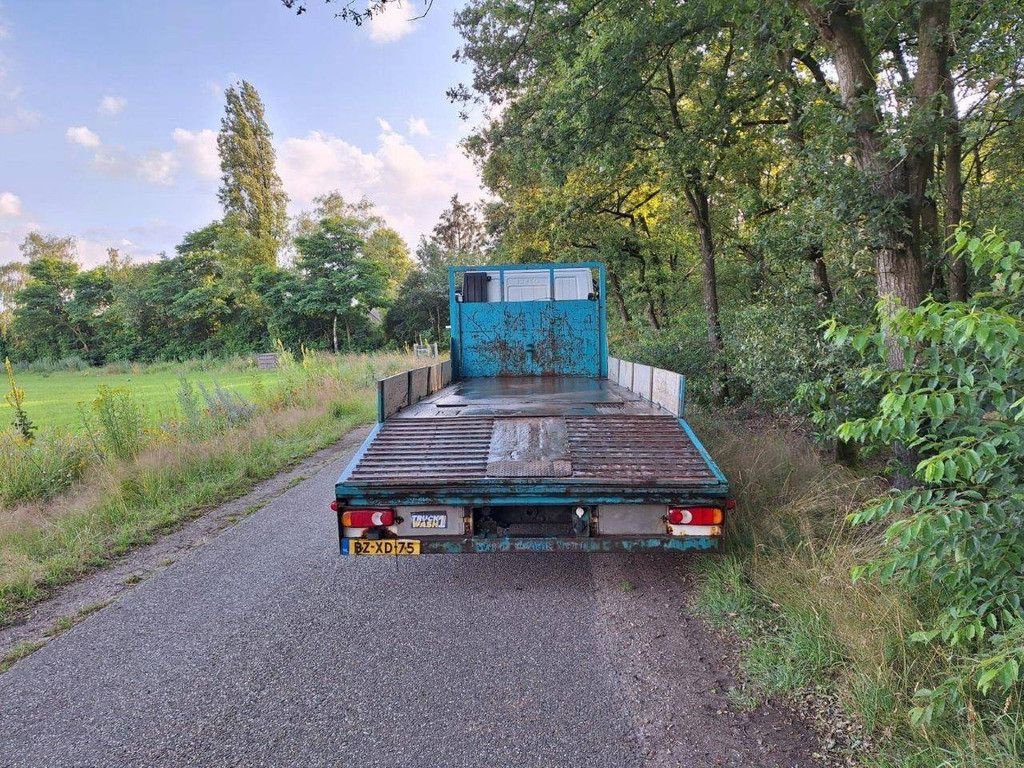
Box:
0;355;412;626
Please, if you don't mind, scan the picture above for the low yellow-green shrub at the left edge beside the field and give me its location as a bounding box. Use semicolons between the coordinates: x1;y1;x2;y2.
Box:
0;432;88;507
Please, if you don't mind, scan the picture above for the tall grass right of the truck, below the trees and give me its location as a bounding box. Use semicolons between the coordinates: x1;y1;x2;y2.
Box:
694;415;1024;768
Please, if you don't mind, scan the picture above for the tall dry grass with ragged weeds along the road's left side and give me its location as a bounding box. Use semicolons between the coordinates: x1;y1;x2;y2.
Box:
0;353;416;625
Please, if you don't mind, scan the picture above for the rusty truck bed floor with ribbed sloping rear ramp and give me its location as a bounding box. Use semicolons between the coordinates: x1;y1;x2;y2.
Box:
338;377;726;504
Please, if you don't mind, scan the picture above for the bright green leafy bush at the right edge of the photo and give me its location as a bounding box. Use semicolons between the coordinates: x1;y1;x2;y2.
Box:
828;227;1024;724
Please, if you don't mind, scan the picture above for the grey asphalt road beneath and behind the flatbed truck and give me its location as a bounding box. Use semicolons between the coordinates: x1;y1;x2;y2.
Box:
0;436;814;768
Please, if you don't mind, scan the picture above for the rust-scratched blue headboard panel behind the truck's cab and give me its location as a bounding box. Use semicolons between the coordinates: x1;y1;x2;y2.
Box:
459;299;607;378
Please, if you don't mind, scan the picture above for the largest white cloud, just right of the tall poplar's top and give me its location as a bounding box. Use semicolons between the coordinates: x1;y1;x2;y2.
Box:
278;121;481;247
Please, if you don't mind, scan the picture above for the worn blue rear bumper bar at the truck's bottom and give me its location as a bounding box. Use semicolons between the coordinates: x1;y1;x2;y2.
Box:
341;536;721;555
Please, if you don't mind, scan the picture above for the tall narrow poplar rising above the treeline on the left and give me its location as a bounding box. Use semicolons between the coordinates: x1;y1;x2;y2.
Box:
217;80;288;266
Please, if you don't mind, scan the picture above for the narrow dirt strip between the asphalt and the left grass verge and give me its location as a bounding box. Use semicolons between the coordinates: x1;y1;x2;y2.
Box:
0;427;370;672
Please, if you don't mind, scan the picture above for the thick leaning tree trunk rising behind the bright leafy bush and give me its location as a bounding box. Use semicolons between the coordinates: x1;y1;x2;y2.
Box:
800;0;931;368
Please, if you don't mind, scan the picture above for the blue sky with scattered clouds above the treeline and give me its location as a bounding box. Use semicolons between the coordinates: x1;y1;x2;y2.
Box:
0;0;481;265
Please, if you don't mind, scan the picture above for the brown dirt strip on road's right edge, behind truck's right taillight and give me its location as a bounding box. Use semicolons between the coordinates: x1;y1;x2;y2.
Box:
591;554;830;768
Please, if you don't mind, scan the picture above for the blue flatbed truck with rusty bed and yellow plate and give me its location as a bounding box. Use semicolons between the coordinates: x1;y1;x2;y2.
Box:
331;262;732;555
